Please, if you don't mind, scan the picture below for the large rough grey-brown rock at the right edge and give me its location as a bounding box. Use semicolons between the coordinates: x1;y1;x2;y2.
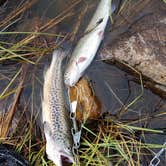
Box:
100;0;166;98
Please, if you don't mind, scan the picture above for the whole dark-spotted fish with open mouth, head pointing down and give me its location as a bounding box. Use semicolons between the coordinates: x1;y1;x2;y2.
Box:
42;50;74;166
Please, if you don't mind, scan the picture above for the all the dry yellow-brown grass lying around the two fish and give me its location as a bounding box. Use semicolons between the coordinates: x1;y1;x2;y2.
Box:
0;0;166;166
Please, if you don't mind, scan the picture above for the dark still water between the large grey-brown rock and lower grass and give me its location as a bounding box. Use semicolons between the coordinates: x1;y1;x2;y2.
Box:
87;61;166;144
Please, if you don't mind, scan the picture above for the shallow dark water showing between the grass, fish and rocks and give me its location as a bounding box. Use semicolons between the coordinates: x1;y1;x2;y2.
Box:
0;0;166;165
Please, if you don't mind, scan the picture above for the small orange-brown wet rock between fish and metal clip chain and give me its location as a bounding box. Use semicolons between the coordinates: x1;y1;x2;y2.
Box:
70;78;101;121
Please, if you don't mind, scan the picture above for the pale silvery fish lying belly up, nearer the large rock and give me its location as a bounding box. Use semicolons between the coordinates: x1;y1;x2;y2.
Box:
64;0;116;87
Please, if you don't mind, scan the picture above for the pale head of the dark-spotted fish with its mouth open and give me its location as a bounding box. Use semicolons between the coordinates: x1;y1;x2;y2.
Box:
44;123;74;166
